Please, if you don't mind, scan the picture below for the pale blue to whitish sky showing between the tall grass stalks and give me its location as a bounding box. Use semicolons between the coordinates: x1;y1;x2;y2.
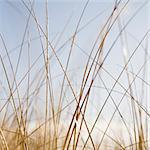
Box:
0;0;150;144
